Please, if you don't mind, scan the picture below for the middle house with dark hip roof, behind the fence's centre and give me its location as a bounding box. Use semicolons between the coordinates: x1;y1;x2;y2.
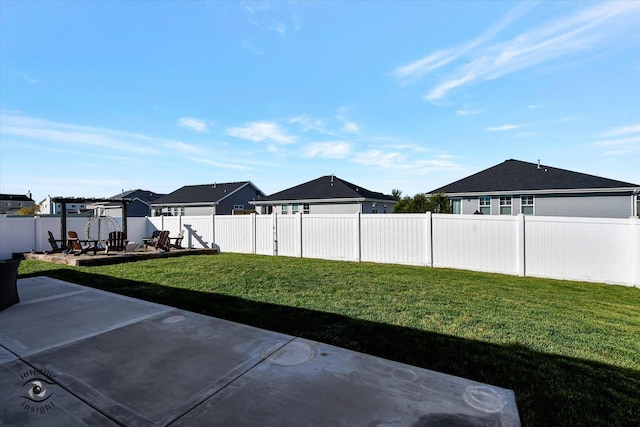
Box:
253;175;396;215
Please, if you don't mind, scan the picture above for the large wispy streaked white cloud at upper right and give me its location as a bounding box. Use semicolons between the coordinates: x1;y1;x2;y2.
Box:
394;2;640;102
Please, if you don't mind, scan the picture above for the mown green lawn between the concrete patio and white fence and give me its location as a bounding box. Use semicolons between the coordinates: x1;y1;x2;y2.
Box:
20;254;640;426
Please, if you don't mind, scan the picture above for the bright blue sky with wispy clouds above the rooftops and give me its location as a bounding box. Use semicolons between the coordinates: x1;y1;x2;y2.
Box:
0;0;640;201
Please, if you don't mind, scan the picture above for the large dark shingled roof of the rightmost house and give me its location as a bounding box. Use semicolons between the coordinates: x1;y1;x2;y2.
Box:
429;159;639;194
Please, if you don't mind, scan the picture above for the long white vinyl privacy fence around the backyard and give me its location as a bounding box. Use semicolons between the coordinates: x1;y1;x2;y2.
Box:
0;213;640;287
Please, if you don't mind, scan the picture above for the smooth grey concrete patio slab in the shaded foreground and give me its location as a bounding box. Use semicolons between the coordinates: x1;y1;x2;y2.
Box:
0;277;520;427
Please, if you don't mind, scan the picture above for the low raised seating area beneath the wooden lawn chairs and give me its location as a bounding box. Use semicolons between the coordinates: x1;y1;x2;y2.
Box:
23;249;219;267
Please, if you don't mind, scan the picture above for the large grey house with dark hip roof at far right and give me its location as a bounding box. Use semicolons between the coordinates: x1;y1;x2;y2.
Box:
429;159;640;218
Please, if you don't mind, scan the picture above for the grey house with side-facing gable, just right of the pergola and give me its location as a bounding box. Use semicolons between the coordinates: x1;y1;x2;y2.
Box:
151;181;264;216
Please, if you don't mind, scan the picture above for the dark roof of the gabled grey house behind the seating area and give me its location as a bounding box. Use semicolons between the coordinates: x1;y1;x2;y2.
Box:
152;181;264;206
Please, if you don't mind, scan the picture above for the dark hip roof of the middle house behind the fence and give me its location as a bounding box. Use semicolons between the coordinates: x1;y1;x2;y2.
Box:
256;175;396;204
